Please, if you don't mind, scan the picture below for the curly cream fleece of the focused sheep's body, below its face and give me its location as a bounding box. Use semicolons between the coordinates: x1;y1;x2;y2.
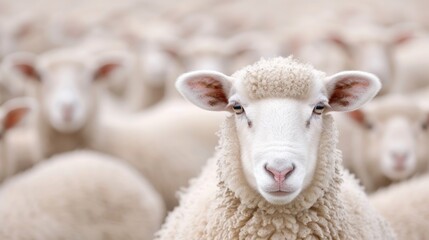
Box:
157;115;395;239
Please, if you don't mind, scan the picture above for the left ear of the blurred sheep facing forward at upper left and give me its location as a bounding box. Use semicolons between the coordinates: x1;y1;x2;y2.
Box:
4;52;41;81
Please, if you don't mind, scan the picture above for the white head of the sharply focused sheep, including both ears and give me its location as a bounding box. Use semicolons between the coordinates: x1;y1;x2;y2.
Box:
176;59;380;205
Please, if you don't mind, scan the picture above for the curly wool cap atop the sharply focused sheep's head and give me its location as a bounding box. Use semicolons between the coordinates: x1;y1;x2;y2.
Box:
232;56;324;100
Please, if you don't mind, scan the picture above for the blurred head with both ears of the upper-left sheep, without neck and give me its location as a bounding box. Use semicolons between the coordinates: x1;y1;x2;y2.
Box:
7;49;122;133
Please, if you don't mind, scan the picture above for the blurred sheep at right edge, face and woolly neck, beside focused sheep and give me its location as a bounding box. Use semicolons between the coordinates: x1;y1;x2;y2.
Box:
336;95;429;193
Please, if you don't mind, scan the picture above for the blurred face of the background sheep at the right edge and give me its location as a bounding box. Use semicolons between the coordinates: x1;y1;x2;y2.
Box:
350;96;428;181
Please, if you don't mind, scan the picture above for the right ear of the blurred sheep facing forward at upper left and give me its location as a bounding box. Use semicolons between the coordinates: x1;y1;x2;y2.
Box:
93;53;130;81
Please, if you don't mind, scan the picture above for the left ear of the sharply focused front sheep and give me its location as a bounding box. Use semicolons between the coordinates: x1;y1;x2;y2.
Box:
176;70;232;111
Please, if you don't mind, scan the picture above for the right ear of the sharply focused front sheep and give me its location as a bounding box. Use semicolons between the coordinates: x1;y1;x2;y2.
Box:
325;71;381;112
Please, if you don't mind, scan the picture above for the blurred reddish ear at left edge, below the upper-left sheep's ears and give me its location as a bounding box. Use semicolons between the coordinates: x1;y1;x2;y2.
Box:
1;98;35;131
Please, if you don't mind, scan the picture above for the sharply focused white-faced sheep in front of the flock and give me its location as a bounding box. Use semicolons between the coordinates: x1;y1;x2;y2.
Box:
156;57;395;239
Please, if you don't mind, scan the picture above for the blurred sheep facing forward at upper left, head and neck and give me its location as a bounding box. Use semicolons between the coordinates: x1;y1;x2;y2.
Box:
3;48;130;157
